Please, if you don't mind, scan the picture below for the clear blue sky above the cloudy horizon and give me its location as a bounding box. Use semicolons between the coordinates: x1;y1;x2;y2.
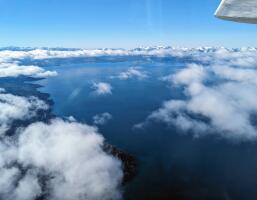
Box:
0;0;257;48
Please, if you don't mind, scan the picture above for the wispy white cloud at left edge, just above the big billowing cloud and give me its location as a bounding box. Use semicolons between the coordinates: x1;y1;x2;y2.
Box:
0;91;48;136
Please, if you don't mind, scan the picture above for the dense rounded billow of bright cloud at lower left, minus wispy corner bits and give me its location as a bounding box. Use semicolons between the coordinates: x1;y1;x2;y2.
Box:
18;119;122;200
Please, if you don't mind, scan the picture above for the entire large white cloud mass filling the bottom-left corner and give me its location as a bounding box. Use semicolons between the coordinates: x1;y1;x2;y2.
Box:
0;119;122;200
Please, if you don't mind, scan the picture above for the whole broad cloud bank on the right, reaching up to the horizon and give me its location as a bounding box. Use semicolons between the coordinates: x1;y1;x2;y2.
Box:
140;49;257;140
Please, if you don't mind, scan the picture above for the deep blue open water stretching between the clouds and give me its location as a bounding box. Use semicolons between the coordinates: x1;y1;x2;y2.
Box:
38;57;257;200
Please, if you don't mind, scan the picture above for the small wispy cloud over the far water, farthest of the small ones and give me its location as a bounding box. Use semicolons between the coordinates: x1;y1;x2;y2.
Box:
117;67;148;80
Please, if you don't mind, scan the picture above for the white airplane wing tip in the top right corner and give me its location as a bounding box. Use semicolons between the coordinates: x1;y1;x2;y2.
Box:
215;0;257;24
